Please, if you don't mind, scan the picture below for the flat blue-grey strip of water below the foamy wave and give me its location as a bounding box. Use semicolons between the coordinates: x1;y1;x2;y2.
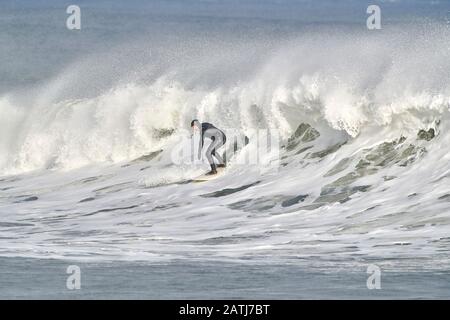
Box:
0;258;450;300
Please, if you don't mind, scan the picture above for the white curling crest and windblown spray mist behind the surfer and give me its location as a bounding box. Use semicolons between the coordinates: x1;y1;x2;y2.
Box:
0;23;450;174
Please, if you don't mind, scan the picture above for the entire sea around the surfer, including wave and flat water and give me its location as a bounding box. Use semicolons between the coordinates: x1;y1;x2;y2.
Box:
0;0;450;299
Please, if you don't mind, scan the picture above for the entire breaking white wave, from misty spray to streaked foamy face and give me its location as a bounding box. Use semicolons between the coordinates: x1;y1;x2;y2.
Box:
0;4;450;282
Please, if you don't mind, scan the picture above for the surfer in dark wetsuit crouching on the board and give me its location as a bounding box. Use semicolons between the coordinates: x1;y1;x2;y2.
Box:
191;120;227;175
